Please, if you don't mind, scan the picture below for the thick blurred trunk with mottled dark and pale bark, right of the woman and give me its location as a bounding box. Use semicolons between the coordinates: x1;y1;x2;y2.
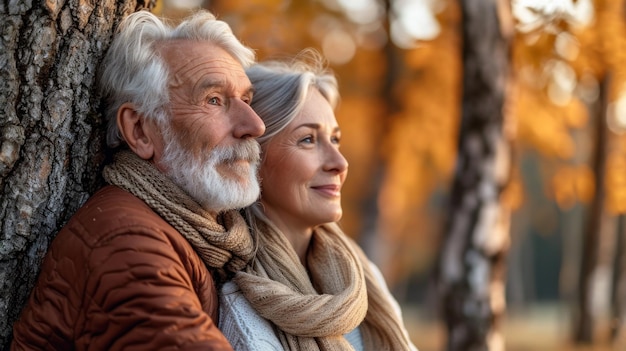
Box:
438;0;512;351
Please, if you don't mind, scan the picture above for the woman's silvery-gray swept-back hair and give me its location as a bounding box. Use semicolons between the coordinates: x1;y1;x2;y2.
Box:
246;49;339;146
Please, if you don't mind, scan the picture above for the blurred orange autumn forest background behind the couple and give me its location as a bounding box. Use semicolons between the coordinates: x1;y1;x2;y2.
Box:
154;0;626;351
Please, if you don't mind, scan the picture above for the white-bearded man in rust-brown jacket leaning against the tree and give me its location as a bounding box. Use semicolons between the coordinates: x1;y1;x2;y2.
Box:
12;11;265;350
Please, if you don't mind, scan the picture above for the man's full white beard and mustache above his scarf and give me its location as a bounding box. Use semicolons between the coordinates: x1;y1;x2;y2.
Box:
161;133;261;212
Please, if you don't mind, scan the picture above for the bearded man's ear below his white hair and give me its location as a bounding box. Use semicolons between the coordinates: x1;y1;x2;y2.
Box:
117;102;155;160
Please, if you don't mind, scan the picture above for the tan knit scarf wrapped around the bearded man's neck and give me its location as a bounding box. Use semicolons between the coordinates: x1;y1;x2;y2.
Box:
103;151;254;279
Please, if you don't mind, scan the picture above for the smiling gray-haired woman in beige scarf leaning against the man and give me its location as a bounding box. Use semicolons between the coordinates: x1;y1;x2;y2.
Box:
220;50;415;351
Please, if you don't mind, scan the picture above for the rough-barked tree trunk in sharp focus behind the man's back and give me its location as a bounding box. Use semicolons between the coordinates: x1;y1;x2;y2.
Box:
0;0;153;349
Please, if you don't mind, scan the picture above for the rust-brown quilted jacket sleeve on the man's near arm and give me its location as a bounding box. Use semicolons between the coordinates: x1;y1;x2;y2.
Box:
76;226;232;350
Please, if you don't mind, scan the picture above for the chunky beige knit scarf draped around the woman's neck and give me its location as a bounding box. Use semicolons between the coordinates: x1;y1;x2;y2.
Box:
234;222;410;351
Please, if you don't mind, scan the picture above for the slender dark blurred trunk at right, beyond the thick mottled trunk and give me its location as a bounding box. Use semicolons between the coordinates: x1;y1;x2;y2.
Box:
574;73;609;344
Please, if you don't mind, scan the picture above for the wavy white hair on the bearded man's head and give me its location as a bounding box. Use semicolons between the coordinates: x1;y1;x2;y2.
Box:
100;11;255;148
